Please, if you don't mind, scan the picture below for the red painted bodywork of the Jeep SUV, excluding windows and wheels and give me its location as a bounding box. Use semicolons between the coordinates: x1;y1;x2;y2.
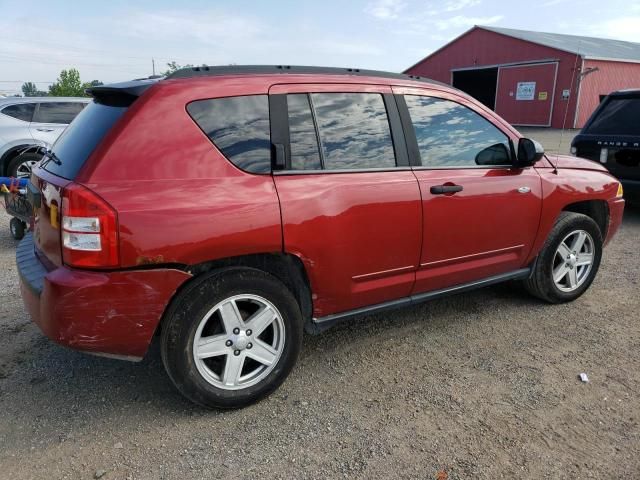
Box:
22;74;624;358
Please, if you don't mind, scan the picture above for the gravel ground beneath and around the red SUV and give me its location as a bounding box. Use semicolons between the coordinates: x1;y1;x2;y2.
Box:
0;193;640;480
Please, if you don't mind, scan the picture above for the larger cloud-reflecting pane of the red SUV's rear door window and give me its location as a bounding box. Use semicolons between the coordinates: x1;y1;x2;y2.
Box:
311;93;396;169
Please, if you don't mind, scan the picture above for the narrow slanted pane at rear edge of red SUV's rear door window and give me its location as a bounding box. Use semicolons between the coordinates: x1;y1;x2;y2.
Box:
287;93;322;170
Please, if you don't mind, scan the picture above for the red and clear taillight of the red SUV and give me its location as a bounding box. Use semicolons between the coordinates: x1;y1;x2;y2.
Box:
61;183;120;268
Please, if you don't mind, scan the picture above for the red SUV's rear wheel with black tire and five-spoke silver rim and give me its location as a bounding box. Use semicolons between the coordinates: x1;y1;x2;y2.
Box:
161;268;303;408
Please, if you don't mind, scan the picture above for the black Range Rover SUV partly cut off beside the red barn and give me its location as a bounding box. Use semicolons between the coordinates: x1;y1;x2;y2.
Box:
571;90;640;197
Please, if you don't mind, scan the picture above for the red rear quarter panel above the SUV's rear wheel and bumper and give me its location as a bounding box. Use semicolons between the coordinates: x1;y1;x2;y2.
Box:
80;78;282;267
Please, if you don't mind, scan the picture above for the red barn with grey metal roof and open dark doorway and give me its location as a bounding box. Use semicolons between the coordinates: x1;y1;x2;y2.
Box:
405;26;640;128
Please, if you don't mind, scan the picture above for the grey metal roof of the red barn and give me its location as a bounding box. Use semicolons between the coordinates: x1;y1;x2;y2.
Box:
478;25;640;62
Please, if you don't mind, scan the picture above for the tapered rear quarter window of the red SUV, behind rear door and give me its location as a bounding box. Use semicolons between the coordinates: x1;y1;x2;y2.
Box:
187;95;271;173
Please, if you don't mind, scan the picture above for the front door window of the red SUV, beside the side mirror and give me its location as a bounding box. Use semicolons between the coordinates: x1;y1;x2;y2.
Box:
404;95;511;167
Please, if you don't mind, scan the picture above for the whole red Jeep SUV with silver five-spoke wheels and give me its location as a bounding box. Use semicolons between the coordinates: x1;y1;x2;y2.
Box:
17;67;624;407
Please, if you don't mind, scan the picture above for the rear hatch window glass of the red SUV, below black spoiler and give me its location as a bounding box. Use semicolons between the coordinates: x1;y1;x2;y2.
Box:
42;101;127;180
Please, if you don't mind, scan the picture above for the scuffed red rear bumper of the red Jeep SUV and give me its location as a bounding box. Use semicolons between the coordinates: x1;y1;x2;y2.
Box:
16;234;191;360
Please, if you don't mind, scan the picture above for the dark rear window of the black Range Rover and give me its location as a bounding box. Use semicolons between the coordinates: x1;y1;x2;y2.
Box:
585;97;640;136
